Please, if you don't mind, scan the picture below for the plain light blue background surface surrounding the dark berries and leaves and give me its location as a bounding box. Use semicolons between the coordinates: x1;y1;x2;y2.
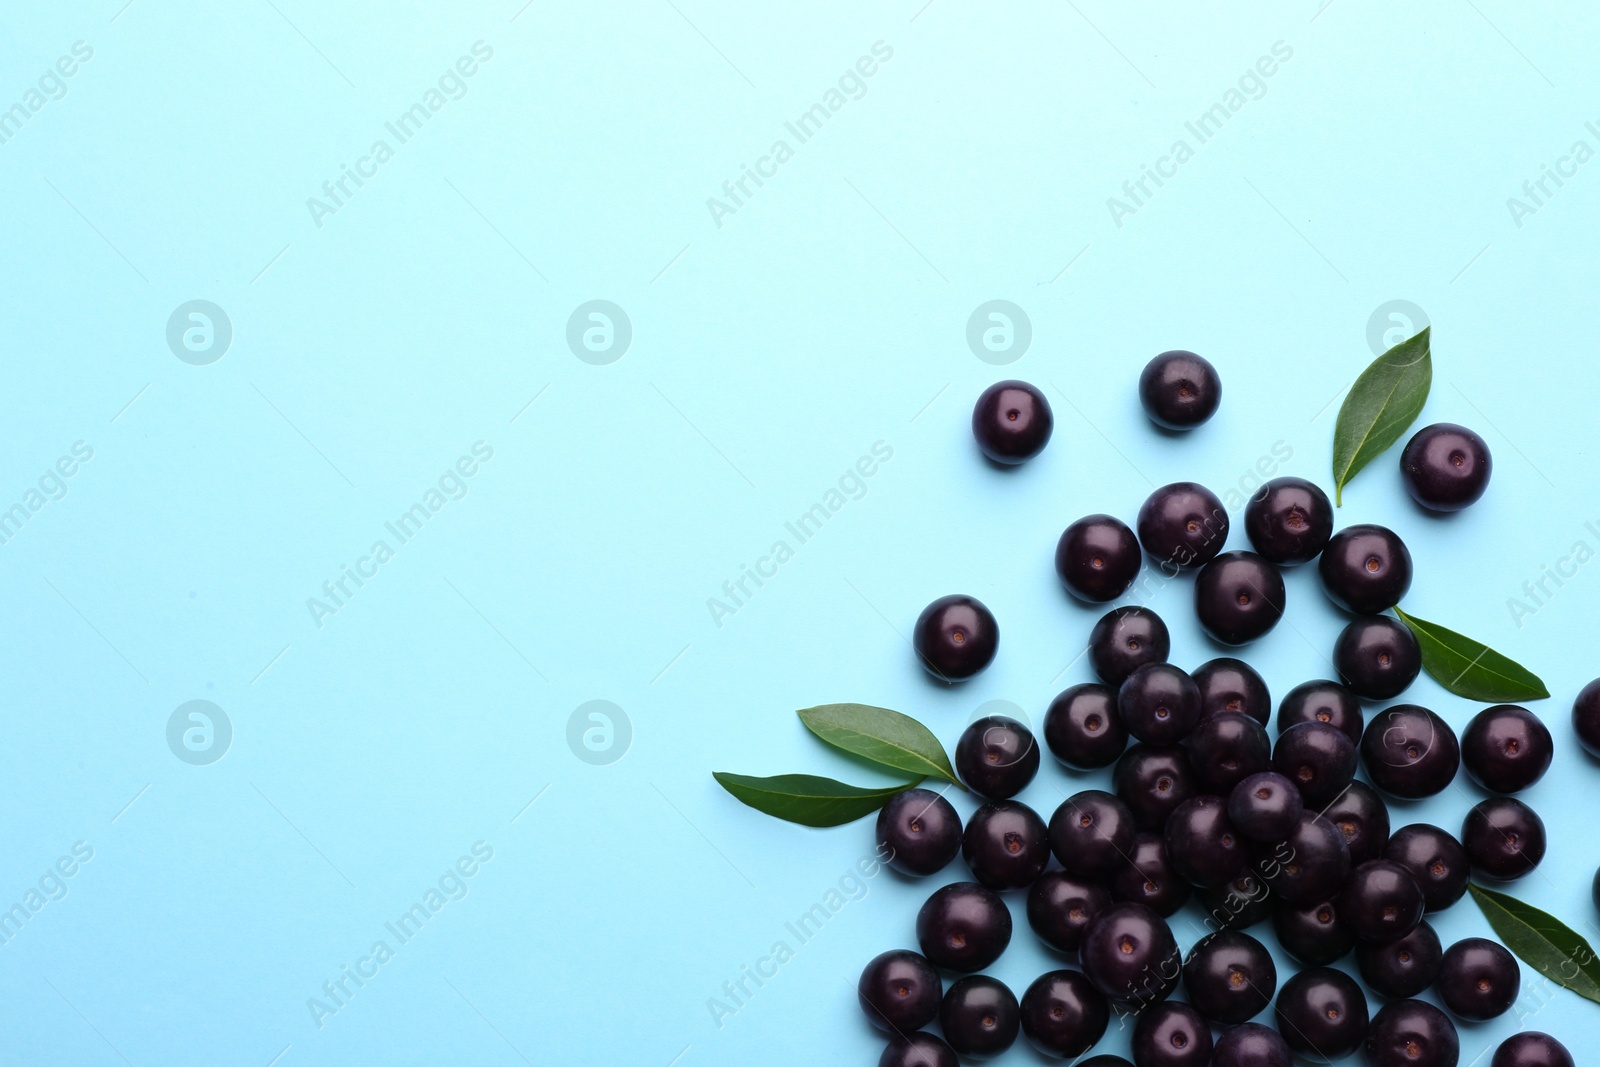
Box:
0;0;1600;1067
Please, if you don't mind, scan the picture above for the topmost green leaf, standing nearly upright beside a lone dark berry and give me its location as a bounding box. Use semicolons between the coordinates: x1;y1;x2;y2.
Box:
1333;326;1434;504
